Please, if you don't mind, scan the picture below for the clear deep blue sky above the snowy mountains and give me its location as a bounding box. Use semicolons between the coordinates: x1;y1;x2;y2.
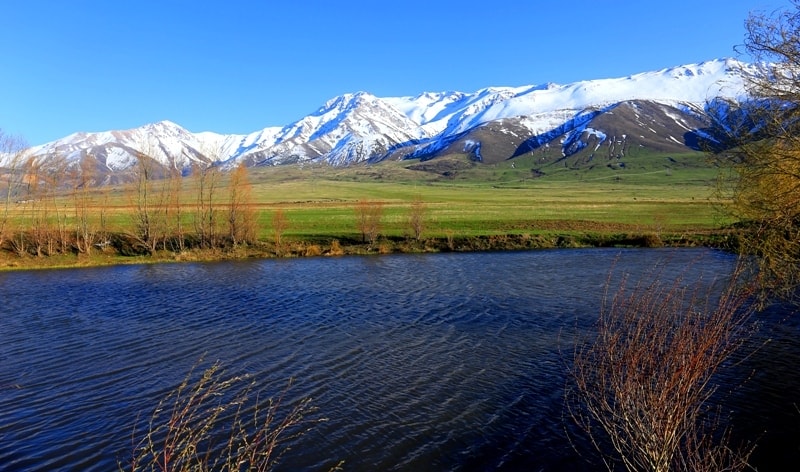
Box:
0;0;789;145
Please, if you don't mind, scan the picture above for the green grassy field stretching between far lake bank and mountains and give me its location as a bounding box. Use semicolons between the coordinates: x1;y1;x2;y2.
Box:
0;153;731;266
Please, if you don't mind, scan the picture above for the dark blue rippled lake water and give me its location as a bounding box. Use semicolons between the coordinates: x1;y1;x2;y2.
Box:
0;249;800;471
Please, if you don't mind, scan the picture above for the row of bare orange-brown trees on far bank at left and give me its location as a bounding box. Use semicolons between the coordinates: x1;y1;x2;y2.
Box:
0;139;259;257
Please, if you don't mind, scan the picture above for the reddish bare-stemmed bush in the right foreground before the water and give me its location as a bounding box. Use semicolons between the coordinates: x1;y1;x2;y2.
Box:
567;271;752;472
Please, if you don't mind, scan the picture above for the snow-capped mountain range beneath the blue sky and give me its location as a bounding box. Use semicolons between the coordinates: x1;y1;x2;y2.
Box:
20;59;750;179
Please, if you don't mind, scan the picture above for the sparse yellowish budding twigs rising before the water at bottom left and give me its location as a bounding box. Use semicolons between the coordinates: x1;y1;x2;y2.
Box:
120;362;321;472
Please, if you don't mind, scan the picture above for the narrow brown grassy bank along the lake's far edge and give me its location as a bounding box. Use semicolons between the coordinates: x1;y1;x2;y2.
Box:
0;230;735;272
